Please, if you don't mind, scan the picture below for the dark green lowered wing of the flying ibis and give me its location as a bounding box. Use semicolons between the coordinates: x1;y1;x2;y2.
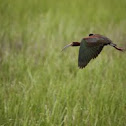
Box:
78;39;104;68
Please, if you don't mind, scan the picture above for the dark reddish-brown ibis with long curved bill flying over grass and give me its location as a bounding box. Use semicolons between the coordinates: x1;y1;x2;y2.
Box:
62;33;125;69
